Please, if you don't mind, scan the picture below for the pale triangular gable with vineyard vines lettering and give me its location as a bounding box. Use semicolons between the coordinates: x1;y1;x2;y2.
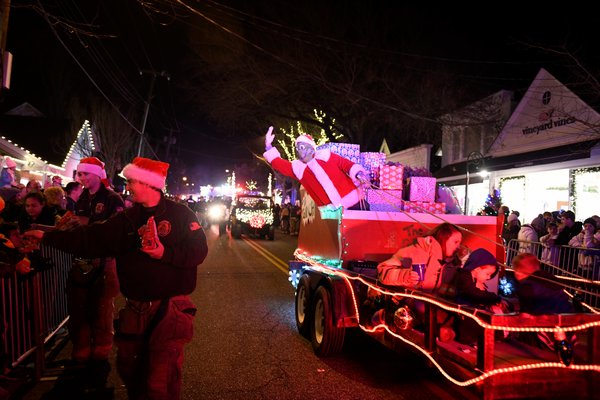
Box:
487;68;600;157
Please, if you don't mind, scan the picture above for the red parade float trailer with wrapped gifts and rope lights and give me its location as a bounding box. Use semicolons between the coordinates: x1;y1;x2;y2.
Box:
289;145;600;399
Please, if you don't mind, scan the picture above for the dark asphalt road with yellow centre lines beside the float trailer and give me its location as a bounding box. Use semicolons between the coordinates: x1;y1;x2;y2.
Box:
14;226;476;400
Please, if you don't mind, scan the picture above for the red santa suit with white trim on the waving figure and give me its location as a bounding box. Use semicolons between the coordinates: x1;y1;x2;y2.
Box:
263;147;365;208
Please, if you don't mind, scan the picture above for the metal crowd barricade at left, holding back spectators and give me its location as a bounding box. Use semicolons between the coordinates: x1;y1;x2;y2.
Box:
0;245;73;371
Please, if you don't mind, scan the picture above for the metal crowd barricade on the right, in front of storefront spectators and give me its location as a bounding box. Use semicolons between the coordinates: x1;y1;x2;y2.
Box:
506;240;600;311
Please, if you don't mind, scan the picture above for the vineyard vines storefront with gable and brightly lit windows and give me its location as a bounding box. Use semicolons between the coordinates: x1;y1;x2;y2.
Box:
436;69;600;223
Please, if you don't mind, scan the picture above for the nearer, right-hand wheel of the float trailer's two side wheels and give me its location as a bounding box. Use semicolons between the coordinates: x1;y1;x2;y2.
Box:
311;286;345;357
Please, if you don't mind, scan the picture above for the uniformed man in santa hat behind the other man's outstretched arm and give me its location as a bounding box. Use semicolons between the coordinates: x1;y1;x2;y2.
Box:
67;157;125;363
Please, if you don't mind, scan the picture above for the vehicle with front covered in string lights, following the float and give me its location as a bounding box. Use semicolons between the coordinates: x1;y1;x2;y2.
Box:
230;195;275;240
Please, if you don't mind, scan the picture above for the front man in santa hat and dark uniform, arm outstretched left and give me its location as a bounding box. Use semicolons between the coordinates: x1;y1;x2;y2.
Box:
25;157;208;399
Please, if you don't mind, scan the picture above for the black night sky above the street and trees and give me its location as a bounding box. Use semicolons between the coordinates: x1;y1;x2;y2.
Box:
4;0;600;184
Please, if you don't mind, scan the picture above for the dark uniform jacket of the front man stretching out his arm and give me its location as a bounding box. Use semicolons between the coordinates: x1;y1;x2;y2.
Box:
42;195;208;301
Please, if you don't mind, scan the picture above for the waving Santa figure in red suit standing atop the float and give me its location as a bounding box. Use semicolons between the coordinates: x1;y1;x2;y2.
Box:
263;126;369;209
